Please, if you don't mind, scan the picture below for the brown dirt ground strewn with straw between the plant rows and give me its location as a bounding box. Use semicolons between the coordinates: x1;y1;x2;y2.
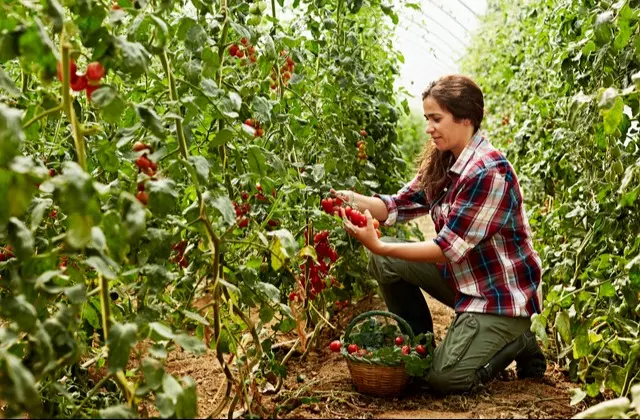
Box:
161;220;583;419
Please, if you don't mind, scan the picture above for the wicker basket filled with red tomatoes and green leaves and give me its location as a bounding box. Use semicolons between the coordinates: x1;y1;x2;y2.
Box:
330;311;433;397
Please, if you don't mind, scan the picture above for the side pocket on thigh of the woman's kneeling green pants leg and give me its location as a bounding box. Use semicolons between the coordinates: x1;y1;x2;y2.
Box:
434;313;480;372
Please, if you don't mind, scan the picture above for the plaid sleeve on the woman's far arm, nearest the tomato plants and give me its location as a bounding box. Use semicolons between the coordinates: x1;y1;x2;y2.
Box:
373;175;429;226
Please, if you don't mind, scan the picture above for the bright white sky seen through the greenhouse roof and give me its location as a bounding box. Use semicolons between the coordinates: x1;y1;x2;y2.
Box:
394;0;487;114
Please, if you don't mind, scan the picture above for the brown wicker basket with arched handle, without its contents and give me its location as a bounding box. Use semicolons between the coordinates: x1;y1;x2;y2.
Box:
343;311;415;397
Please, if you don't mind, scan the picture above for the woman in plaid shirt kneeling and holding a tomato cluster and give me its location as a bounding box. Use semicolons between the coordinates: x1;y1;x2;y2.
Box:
332;75;546;392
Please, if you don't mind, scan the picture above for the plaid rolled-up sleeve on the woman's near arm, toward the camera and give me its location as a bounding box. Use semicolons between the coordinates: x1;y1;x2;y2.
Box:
434;167;519;263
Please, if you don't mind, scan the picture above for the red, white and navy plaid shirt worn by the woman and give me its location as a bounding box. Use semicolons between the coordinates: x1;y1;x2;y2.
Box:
375;133;542;317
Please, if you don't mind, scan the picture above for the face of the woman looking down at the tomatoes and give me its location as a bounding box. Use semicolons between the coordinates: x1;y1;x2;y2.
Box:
422;96;474;158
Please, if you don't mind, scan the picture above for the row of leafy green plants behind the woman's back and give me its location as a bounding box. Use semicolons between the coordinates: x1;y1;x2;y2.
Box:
464;0;640;408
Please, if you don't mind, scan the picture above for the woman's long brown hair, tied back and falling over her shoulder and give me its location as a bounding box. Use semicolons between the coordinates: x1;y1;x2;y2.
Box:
418;75;484;201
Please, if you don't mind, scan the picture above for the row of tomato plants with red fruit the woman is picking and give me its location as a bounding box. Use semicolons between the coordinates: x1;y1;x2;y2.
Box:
0;0;415;417
